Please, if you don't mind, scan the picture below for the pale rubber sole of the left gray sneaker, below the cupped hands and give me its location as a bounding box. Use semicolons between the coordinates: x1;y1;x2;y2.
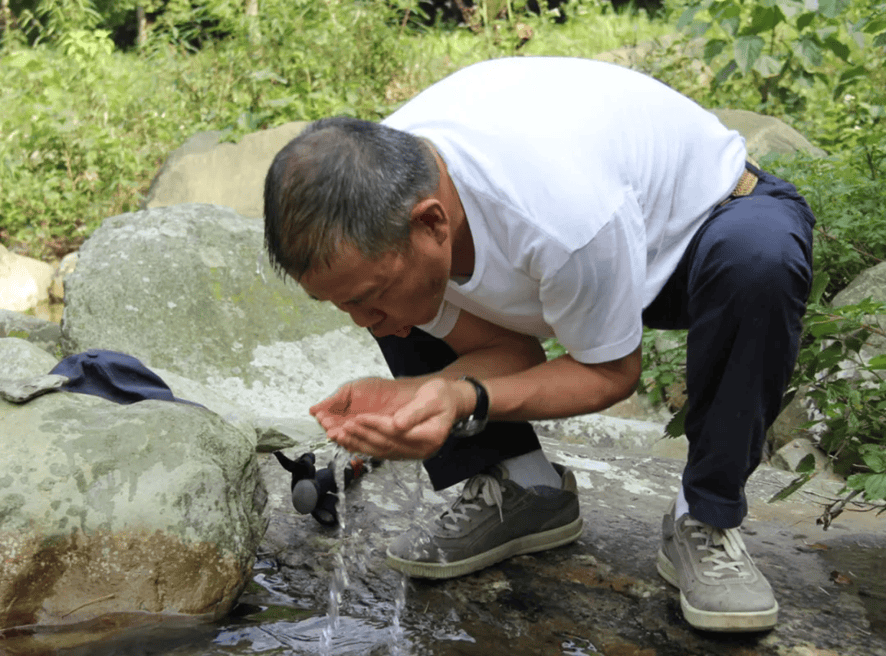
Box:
386;517;584;579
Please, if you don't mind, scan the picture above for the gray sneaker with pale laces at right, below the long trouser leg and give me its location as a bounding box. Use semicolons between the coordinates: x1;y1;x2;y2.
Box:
658;506;778;631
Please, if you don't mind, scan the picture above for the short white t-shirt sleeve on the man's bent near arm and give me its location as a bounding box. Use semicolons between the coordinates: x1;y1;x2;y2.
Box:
540;207;646;364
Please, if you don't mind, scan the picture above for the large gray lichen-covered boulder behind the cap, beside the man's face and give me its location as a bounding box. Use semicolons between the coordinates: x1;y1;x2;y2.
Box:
62;205;387;422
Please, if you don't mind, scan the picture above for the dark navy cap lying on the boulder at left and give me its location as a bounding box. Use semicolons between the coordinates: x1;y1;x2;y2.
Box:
49;349;198;405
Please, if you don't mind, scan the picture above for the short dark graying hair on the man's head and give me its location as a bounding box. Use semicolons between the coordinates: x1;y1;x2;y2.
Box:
265;117;440;280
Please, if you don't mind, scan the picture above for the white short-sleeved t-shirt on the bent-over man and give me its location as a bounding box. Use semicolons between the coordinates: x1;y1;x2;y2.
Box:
383;57;747;363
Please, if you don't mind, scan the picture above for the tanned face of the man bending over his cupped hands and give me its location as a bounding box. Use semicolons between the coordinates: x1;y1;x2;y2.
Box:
299;230;450;337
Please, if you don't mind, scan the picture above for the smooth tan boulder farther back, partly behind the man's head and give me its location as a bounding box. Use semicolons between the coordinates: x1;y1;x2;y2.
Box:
143;121;307;218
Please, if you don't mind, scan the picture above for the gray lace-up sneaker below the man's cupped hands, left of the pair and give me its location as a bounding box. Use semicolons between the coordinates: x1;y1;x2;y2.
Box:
387;464;582;579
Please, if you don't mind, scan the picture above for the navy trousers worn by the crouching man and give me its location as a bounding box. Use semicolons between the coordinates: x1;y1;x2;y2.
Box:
378;164;815;528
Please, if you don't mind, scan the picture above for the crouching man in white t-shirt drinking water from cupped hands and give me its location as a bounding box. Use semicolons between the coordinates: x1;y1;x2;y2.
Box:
265;58;814;631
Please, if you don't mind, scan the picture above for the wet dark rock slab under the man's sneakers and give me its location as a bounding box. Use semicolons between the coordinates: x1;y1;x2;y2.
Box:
244;440;886;656
